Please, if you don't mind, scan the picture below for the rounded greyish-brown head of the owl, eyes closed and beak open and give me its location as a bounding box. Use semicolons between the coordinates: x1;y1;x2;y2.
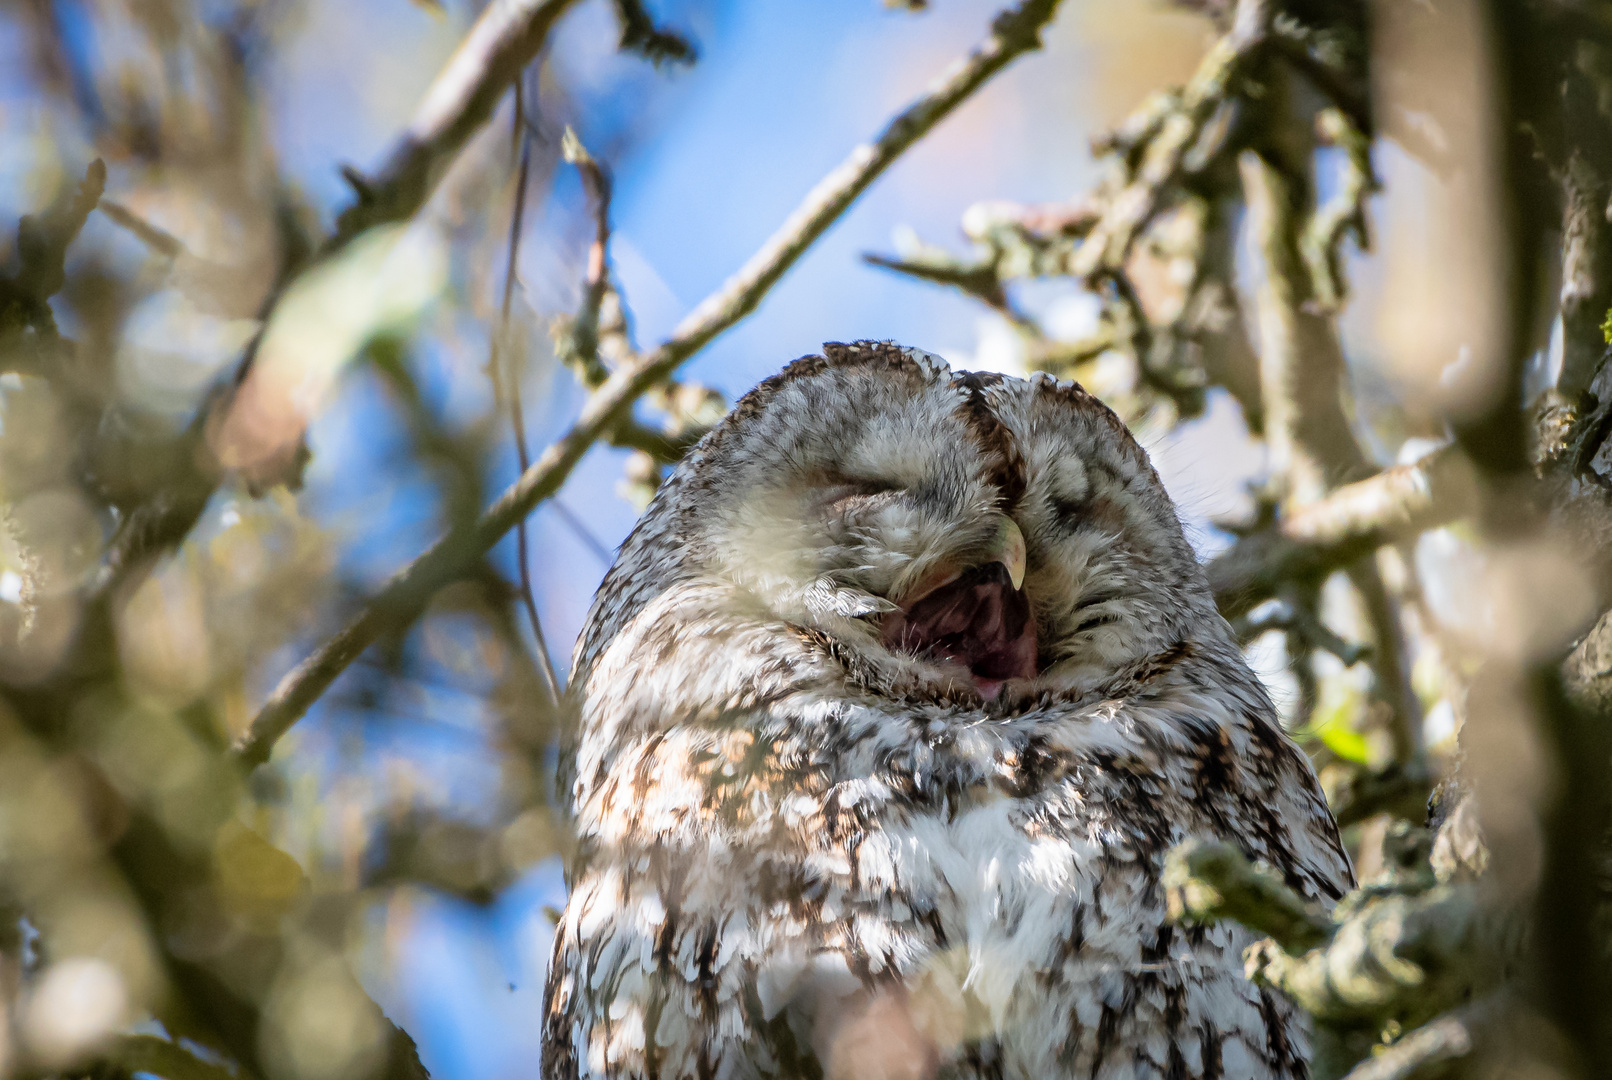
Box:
577;342;1230;706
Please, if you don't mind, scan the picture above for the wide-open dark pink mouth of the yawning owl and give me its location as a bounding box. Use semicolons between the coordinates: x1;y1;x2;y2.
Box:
883;563;1035;701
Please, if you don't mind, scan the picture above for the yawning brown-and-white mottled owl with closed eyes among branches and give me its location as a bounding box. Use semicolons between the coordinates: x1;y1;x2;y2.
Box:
542;342;1352;1080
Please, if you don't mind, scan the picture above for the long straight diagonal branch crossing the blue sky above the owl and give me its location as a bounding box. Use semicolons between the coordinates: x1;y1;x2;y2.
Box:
235;0;1057;766
